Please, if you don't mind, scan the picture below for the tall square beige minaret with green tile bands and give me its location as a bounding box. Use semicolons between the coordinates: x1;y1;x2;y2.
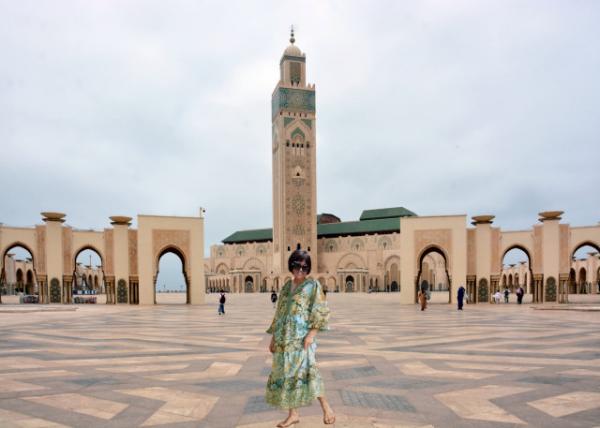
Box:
272;28;318;276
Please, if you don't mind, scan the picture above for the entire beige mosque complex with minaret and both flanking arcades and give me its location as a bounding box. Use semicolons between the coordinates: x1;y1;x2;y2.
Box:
0;32;600;304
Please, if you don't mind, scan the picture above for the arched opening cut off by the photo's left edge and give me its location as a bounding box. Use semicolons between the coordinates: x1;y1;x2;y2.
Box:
0;243;37;303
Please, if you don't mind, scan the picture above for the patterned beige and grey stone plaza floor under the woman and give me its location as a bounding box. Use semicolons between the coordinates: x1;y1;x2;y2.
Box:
0;294;600;428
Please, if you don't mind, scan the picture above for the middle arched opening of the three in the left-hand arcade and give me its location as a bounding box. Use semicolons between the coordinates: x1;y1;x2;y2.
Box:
73;245;106;303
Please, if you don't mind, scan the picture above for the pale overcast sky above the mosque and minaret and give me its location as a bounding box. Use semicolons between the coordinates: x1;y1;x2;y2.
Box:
0;0;600;288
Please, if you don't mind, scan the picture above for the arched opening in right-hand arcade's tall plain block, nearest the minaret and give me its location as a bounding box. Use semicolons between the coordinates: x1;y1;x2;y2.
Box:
414;246;452;303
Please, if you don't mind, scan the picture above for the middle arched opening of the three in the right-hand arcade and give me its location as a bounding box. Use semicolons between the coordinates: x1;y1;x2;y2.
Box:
500;245;532;302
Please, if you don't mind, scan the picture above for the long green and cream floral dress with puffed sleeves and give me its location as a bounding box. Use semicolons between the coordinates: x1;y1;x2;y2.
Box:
266;279;329;409
